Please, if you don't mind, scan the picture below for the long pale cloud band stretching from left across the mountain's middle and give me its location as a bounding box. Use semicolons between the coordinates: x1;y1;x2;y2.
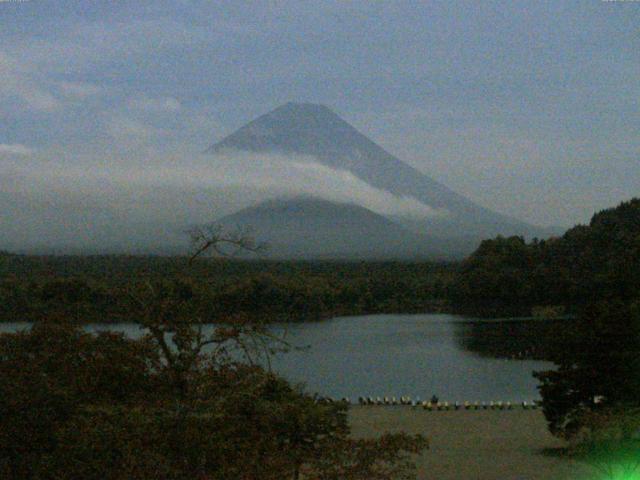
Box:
3;152;447;223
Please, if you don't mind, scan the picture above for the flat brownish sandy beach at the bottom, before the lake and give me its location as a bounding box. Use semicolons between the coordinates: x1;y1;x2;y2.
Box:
349;406;595;480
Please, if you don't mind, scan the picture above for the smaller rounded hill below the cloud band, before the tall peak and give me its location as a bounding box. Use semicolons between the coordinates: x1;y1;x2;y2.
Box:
216;197;462;258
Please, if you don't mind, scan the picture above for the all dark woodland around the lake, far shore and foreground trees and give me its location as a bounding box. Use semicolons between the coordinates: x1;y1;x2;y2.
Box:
0;199;640;480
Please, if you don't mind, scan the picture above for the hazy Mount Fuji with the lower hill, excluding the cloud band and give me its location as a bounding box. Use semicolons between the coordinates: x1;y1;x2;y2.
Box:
205;103;551;258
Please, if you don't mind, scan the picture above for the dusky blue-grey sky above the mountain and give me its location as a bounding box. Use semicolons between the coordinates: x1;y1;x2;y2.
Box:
0;0;640;226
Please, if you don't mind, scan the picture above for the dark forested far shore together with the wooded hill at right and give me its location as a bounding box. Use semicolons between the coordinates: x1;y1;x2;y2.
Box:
0;199;640;326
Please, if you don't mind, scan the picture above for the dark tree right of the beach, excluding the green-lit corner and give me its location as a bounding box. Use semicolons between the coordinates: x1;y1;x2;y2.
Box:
535;300;640;438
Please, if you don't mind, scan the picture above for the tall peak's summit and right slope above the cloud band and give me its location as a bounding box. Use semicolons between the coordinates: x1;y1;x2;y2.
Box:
207;103;547;239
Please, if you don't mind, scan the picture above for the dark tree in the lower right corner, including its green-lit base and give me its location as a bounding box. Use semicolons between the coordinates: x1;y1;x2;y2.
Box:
535;299;640;479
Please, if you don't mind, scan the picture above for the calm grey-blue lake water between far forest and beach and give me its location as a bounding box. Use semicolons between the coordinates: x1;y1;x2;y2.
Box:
0;314;553;402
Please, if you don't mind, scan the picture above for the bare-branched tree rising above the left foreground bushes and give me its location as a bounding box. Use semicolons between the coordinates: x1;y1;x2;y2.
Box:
129;224;278;395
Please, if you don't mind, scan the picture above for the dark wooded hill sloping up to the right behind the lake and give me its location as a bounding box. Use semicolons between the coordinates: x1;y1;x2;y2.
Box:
449;198;640;315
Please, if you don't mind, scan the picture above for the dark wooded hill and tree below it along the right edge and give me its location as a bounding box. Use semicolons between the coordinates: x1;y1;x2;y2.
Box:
451;199;640;473
